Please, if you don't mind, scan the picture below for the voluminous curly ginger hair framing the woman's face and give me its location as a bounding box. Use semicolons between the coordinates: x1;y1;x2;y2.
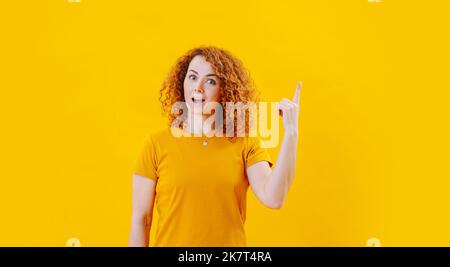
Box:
159;46;258;141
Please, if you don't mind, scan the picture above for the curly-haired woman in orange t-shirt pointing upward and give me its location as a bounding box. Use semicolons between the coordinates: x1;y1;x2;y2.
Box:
129;47;300;247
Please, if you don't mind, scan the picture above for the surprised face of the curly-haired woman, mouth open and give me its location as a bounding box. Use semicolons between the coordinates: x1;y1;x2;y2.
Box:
184;55;221;114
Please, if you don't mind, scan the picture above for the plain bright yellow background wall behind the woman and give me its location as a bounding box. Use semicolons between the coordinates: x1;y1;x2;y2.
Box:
0;0;450;246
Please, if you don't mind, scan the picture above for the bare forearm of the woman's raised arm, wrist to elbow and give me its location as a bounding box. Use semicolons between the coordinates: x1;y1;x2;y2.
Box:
264;131;298;208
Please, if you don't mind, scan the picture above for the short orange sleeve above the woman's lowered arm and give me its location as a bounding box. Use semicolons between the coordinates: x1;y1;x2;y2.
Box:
134;136;158;181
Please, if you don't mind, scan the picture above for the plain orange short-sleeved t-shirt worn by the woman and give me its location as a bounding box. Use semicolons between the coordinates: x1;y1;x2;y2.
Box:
134;128;272;247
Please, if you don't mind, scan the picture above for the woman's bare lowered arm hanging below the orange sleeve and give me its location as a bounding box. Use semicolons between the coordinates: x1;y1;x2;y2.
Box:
128;174;156;247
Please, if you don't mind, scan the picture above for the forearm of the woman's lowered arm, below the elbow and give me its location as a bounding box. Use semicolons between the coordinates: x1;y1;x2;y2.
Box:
128;215;151;247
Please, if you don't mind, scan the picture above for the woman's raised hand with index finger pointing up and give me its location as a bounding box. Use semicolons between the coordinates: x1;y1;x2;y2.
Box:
278;82;302;136
